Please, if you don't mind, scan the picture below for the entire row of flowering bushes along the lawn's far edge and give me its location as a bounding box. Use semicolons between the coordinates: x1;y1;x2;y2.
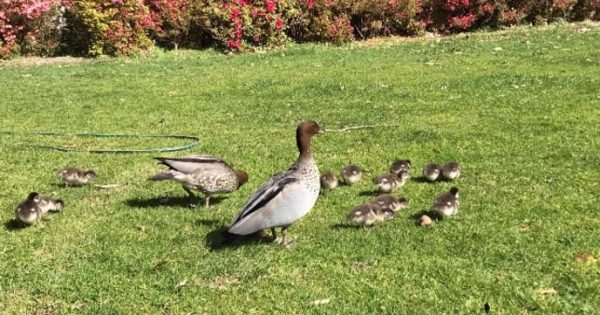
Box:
0;0;600;58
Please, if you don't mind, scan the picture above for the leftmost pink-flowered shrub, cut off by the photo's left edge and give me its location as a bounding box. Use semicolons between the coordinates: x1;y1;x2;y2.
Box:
0;0;62;58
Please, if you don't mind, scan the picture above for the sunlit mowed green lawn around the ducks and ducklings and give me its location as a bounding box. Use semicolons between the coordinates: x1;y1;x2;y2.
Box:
0;24;600;314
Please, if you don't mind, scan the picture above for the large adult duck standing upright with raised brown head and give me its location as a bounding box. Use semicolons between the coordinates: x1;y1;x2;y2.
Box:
227;120;325;246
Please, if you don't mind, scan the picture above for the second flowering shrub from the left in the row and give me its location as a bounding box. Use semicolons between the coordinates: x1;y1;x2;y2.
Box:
65;0;154;56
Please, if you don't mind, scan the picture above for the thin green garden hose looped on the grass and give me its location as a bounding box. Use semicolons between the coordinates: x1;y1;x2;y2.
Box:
0;131;200;153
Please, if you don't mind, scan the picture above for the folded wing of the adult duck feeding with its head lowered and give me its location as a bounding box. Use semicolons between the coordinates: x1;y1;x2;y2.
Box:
155;155;232;174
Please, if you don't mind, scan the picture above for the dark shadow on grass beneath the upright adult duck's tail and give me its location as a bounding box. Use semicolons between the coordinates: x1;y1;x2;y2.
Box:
205;226;273;251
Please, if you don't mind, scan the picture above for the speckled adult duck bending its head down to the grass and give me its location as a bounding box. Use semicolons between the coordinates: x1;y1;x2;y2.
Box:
149;155;248;208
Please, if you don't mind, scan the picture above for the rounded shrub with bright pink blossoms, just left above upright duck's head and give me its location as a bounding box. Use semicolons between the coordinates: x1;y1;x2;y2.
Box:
196;0;293;52
